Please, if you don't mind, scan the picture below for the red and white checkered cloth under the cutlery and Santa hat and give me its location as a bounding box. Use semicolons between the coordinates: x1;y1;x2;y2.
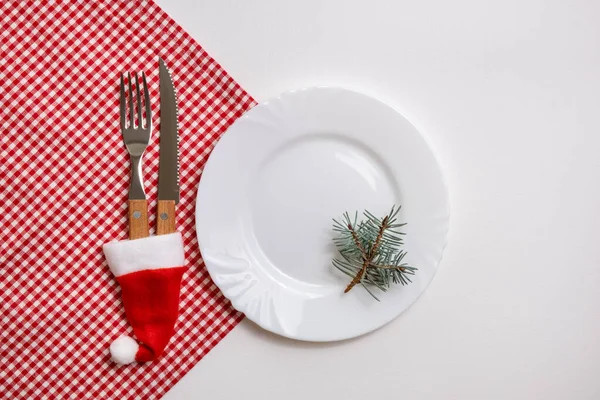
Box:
0;0;254;399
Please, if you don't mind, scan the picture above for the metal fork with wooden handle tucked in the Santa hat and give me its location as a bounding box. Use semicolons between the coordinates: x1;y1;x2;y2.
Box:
120;72;152;239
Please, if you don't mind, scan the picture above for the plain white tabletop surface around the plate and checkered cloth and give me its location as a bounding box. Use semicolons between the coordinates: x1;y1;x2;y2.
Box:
158;0;600;400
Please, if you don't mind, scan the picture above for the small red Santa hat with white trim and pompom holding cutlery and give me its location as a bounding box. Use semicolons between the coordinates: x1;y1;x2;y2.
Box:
103;232;185;364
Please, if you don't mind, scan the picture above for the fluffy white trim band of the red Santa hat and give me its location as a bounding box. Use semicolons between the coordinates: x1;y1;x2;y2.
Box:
103;232;185;276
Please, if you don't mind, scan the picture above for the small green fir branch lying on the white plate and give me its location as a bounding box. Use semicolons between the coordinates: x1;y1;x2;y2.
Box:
333;206;417;300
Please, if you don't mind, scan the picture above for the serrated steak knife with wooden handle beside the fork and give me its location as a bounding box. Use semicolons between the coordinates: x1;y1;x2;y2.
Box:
156;58;179;235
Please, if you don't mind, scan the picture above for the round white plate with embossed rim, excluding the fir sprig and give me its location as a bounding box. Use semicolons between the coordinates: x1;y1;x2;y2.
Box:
196;88;449;341
